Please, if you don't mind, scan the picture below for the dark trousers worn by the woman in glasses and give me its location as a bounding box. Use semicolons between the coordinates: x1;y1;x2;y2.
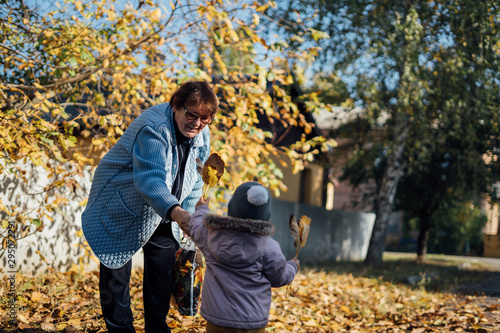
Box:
99;226;179;333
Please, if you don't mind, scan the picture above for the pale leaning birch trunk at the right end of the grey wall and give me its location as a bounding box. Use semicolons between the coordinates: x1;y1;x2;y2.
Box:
365;129;408;266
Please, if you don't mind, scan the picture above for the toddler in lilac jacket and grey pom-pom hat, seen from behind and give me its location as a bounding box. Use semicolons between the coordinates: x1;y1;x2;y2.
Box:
189;182;300;333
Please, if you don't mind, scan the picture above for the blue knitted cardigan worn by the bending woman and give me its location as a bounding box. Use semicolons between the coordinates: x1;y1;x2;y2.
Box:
82;103;210;268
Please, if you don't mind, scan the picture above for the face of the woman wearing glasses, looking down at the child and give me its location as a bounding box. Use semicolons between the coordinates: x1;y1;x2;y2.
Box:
174;106;212;138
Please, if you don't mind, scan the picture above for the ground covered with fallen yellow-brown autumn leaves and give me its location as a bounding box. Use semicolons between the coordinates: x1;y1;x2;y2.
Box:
0;253;500;333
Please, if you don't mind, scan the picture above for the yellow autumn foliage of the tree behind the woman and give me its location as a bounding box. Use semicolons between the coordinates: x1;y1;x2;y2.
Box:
0;0;334;244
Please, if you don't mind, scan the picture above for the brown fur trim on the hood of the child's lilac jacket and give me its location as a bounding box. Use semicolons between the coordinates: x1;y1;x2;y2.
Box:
203;214;275;236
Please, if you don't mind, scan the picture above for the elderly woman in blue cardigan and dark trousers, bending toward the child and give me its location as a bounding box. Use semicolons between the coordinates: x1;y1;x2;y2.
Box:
82;81;218;332
